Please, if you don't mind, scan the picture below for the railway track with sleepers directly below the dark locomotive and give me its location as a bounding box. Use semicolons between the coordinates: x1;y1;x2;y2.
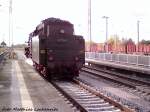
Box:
52;79;133;112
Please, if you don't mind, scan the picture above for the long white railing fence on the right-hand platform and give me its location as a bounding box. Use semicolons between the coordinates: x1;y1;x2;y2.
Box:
85;52;150;67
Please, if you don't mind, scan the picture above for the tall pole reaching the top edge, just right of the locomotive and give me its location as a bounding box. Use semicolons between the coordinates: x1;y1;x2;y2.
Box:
88;0;92;52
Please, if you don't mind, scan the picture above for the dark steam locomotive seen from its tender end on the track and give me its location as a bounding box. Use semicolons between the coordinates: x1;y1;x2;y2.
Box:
26;18;85;79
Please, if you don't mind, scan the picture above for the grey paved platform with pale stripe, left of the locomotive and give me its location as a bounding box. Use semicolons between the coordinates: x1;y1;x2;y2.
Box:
0;51;73;112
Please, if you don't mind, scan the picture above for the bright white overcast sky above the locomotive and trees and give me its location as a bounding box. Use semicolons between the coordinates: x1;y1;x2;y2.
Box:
0;0;150;44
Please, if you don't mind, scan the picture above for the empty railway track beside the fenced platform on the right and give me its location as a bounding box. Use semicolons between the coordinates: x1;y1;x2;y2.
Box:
82;66;150;101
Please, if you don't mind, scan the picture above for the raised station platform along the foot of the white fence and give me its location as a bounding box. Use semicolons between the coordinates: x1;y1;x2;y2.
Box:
85;59;150;75
